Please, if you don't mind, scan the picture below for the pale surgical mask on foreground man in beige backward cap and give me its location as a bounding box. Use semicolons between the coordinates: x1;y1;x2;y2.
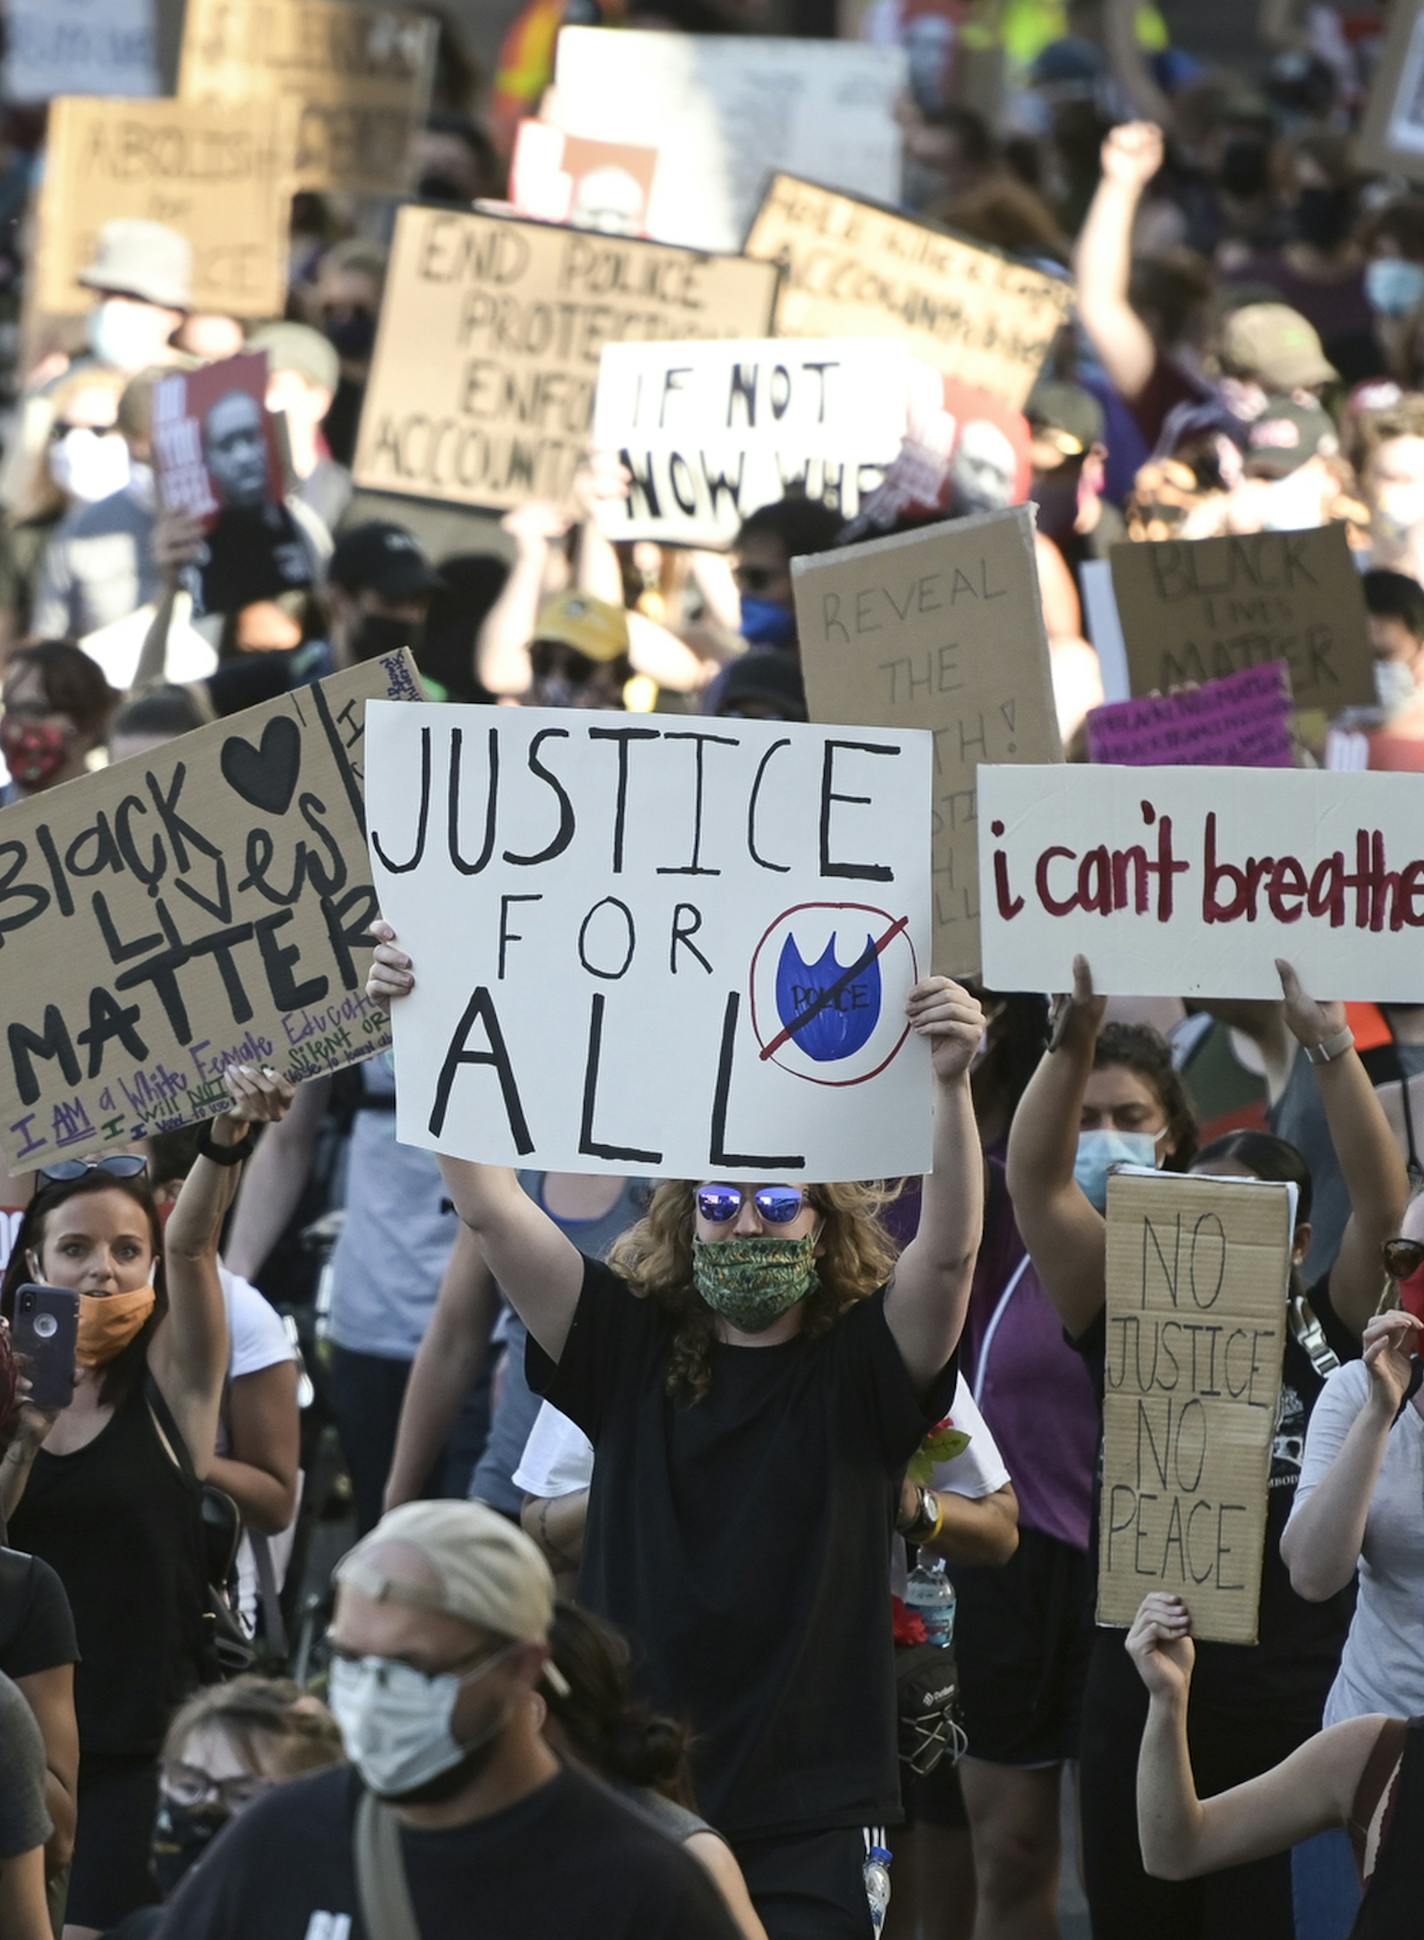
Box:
330;1643;516;1798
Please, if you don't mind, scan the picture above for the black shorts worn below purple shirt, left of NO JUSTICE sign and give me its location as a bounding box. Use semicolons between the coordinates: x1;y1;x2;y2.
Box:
953;1529;1092;1765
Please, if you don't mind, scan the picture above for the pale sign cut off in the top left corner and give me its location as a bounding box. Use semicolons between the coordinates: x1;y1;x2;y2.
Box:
0;0;161;103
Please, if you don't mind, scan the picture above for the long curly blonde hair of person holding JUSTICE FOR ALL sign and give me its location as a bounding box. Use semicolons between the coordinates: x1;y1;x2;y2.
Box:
609;1180;896;1405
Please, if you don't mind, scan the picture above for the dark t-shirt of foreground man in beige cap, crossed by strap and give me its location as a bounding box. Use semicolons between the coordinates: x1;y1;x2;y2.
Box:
159;1769;735;1940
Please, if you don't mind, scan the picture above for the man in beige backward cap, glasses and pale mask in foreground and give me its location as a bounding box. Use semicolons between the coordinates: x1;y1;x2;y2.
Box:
161;1502;737;1940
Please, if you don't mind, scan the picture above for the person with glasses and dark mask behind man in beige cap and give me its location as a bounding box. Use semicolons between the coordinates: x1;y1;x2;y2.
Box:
107;1676;345;1940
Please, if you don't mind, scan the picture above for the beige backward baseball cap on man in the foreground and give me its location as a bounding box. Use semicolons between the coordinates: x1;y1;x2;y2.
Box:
334;1502;568;1696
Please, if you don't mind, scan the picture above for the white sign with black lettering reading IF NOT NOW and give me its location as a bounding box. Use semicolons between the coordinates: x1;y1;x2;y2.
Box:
594;340;941;549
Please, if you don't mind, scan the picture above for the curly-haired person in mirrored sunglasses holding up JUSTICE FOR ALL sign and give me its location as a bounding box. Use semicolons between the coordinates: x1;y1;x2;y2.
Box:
369;925;984;1940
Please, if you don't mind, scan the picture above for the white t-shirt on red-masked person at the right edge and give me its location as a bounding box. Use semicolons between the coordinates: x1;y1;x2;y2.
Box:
1290;1360;1424;1725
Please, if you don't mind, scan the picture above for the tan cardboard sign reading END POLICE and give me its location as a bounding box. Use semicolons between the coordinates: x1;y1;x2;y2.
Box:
355;206;776;510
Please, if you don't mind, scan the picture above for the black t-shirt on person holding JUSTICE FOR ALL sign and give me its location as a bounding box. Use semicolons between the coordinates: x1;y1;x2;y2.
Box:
526;1259;955;1835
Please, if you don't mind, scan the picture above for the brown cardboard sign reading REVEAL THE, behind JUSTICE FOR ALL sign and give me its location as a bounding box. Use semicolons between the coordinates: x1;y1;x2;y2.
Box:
792;506;1063;976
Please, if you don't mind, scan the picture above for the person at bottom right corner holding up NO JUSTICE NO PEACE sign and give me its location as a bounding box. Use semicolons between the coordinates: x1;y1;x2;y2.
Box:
1127;1593;1424;1940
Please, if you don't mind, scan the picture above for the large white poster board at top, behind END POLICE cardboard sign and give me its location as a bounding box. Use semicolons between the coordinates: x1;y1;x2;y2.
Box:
551;27;910;250
